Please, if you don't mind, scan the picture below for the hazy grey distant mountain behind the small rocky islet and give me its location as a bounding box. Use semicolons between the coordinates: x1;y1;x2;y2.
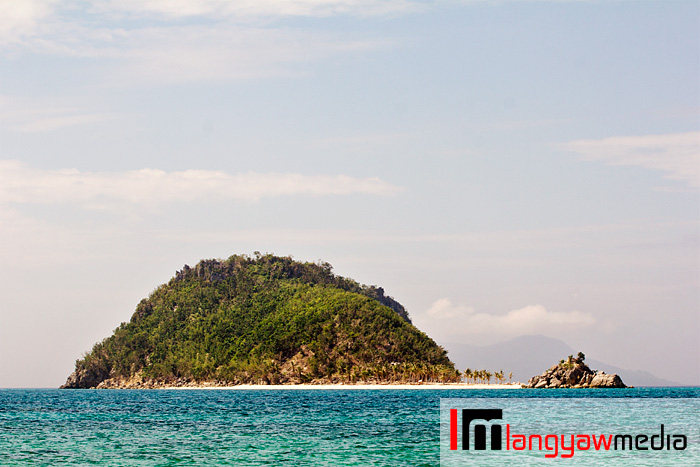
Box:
444;336;681;386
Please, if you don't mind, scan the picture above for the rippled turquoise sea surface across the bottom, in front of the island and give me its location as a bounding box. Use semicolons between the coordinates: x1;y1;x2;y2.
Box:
0;388;700;467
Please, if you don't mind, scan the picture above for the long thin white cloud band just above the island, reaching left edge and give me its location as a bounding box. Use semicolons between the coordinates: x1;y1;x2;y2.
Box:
0;161;400;208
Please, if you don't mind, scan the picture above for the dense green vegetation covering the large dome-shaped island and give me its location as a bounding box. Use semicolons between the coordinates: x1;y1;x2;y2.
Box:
64;253;459;387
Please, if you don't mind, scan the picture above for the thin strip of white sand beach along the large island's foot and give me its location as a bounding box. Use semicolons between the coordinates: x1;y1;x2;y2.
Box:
163;383;522;391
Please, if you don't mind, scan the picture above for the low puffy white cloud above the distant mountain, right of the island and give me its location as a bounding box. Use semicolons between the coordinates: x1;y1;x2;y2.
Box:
417;298;596;341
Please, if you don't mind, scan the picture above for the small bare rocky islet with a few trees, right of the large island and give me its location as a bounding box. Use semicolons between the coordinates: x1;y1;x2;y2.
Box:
523;353;627;389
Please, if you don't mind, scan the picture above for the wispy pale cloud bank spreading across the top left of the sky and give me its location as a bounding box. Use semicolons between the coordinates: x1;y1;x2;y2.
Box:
0;0;394;85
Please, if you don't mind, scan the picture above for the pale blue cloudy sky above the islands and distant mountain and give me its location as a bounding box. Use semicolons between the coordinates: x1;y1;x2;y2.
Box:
0;0;700;387
